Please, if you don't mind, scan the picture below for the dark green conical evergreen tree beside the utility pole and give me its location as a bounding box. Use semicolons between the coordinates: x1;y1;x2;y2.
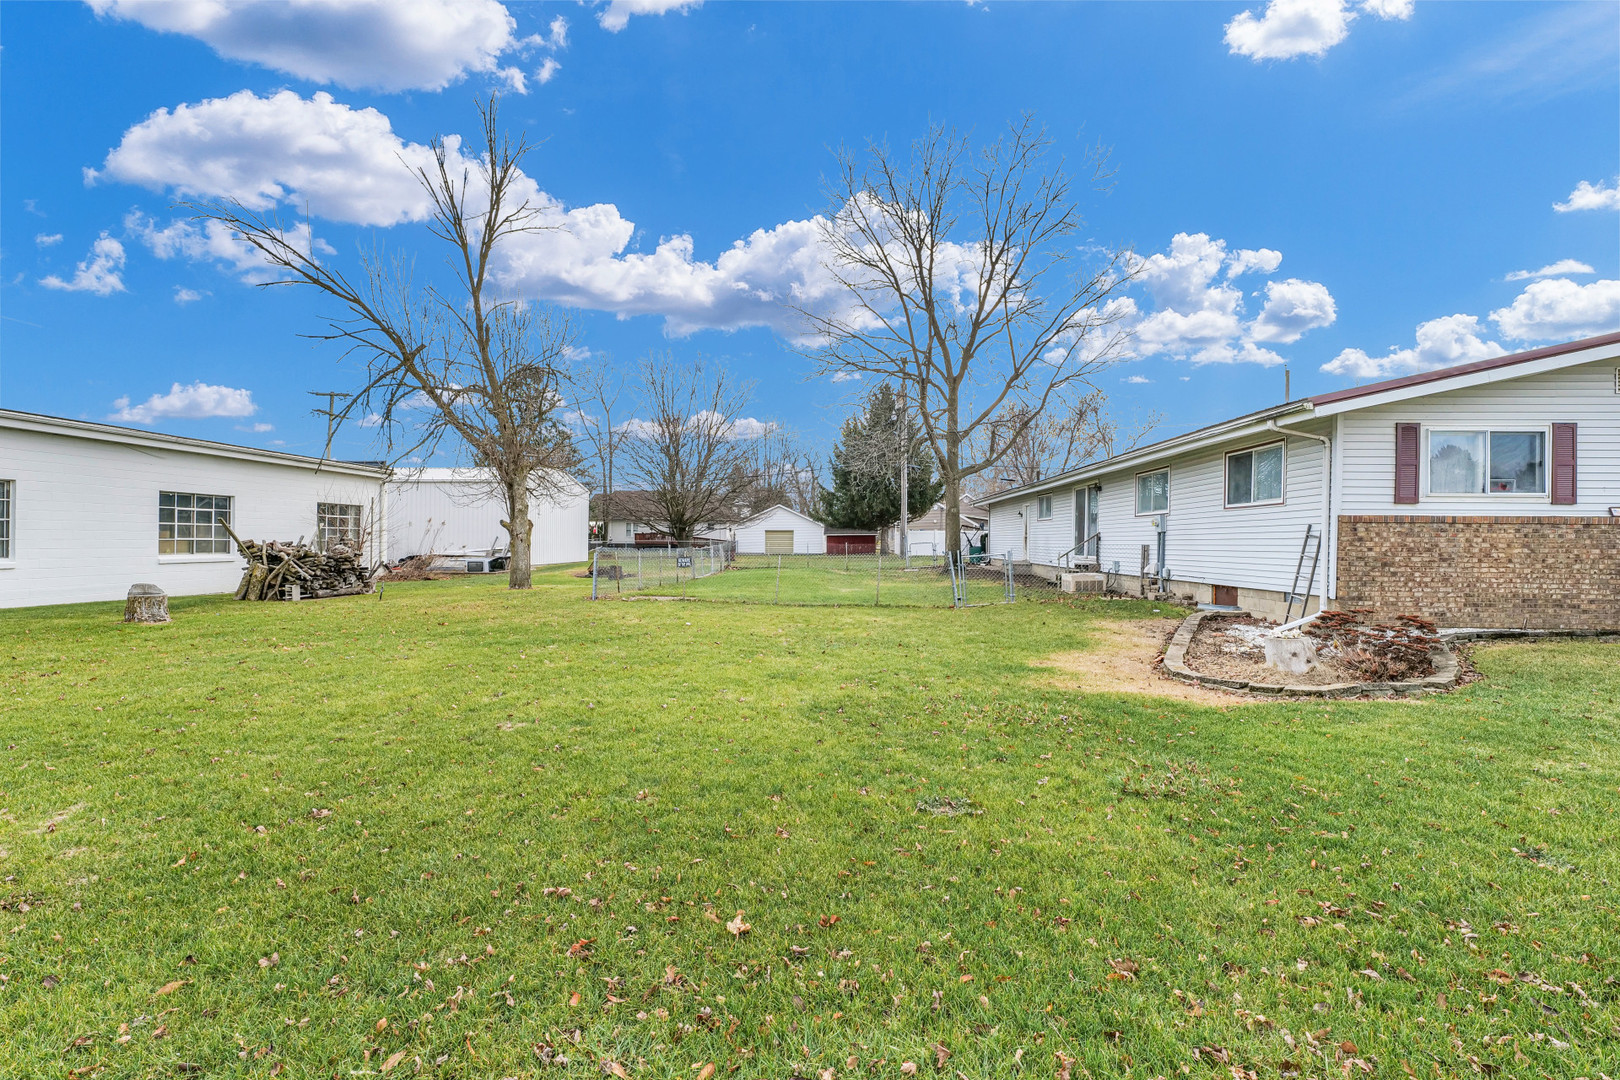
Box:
820;382;944;529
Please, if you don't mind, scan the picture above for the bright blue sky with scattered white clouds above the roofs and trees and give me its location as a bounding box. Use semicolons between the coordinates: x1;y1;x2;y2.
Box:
0;0;1620;457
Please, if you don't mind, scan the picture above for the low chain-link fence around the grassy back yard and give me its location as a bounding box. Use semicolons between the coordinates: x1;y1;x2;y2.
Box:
591;542;1082;607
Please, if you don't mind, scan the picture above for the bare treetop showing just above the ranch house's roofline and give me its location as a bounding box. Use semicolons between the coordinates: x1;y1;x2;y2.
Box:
987;390;1160;489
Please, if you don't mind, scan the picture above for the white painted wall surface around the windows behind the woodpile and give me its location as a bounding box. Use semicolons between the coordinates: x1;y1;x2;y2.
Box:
0;427;386;607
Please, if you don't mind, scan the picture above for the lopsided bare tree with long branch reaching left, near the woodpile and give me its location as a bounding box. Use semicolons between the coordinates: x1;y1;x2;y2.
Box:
193;99;575;589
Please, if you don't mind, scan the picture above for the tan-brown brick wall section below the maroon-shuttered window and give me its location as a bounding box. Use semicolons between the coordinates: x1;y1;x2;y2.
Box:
1338;515;1620;630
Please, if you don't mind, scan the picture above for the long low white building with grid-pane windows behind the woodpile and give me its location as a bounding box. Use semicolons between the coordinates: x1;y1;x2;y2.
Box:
0;410;389;607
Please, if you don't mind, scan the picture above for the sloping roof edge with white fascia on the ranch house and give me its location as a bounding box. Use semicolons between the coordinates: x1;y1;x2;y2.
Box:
985;334;1620;504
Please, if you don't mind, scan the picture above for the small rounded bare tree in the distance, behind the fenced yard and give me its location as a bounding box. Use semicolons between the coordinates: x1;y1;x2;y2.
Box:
624;355;758;542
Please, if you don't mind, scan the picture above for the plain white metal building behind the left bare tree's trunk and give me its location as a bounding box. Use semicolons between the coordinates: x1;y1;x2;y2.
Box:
387;468;590;567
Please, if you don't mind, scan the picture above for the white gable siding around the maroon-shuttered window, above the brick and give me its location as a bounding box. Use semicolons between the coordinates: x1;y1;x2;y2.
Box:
1338;359;1620;517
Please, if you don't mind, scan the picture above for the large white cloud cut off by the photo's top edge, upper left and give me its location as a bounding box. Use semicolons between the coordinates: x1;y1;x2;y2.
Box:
89;0;518;91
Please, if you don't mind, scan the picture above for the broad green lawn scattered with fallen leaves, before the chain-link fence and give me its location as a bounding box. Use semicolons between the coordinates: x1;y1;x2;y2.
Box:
0;572;1620;1080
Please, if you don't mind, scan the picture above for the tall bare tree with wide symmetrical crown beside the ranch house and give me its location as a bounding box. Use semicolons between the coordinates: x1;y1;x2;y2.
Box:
800;117;1132;551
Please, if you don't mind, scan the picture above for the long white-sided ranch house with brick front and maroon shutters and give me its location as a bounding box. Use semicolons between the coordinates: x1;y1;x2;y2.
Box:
987;334;1620;628
